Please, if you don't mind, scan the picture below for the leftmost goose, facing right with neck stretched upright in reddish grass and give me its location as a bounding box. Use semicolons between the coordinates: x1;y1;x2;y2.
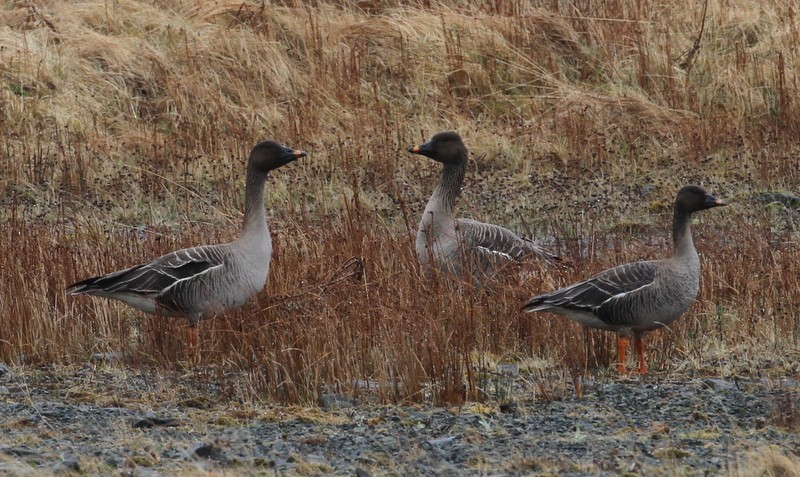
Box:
67;141;306;349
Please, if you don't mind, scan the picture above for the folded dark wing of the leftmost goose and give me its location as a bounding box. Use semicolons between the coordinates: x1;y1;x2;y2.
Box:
67;245;225;311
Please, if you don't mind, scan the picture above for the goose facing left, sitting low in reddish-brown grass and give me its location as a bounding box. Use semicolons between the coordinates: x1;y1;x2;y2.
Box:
407;131;558;283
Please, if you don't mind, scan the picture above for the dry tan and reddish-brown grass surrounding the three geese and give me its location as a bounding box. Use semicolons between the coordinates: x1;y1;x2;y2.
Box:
0;0;800;402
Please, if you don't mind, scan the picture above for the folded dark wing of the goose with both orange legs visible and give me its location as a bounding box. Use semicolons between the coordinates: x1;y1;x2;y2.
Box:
522;261;660;314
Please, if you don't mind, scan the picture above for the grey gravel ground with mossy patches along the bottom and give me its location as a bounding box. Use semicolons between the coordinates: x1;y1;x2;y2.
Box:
0;365;800;477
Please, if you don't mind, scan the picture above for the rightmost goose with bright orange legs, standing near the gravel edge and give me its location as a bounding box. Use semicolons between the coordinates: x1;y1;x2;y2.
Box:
522;185;726;374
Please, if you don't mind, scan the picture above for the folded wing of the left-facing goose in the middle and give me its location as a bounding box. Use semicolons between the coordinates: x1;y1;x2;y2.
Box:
458;219;558;263
